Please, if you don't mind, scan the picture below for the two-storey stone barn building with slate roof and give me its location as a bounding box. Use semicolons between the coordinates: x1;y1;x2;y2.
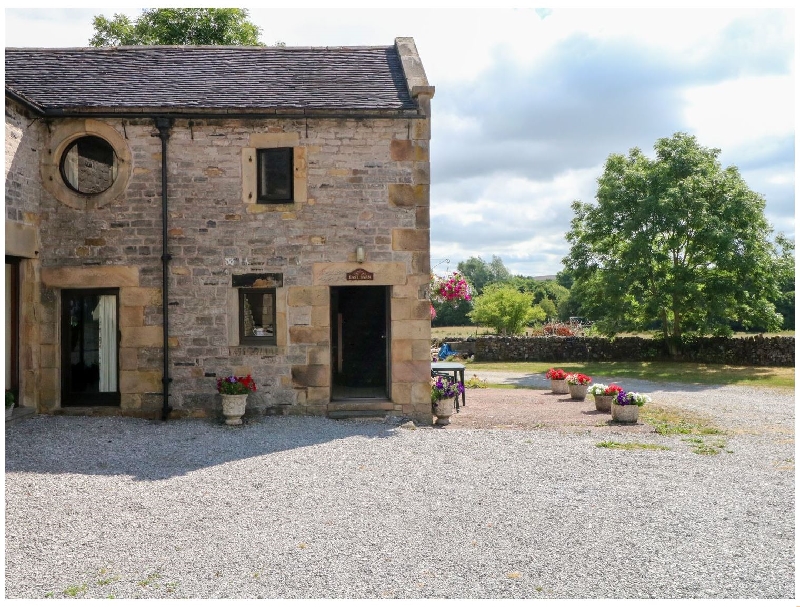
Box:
5;38;434;423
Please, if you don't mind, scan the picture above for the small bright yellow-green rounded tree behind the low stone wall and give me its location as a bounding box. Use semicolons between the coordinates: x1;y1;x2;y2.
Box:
469;284;545;335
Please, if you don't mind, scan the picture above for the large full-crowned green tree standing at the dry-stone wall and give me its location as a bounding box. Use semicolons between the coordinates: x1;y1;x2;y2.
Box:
564;133;782;353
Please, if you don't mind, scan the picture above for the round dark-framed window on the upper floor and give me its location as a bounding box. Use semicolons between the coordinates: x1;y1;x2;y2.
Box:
60;135;117;194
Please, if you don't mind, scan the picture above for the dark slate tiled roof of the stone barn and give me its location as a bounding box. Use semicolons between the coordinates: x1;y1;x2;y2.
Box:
5;46;417;115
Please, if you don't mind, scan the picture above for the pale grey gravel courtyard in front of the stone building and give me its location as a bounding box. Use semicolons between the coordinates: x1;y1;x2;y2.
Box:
5;382;795;604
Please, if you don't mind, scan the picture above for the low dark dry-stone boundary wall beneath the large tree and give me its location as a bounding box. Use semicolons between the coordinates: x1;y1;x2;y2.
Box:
472;335;795;367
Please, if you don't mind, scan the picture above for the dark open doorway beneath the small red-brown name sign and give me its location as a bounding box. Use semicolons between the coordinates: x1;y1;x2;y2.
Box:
331;286;391;400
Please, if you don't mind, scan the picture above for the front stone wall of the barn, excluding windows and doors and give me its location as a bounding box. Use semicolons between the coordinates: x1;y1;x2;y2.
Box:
26;111;430;419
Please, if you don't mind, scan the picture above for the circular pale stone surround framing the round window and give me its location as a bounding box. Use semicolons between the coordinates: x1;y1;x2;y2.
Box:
40;119;132;211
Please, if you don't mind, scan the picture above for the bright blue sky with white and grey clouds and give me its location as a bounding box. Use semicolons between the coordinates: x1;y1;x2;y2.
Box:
5;3;796;276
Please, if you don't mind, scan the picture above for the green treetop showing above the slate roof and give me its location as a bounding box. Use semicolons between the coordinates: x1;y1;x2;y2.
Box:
89;8;264;46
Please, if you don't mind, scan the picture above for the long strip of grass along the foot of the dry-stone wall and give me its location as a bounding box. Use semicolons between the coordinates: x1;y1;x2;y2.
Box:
466;361;795;390
